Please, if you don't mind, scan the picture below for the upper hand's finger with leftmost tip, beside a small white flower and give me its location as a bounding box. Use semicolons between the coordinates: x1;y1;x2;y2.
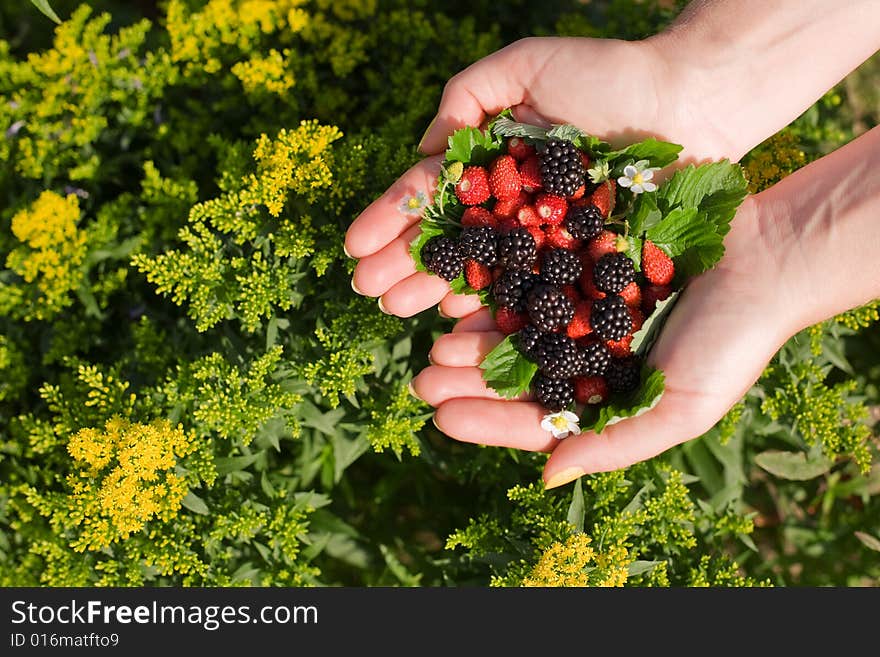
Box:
345;156;443;258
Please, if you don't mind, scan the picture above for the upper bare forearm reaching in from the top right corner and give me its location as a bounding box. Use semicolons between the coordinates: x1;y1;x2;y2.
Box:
649;0;880;157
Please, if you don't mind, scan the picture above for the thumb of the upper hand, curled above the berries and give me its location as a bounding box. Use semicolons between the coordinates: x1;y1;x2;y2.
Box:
419;39;543;153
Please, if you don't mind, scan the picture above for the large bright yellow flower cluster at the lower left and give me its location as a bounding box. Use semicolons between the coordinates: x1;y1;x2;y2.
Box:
67;417;195;552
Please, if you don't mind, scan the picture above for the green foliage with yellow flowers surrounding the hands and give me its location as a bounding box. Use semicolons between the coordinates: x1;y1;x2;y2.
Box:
0;0;880;586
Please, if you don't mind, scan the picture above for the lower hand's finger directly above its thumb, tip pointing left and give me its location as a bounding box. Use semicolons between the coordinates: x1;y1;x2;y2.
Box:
434;399;559;452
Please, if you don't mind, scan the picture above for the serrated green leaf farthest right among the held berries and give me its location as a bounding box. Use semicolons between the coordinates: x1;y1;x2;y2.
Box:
657;160;748;236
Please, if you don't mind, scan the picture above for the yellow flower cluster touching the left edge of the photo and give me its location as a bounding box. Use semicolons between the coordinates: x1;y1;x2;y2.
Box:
0;191;87;320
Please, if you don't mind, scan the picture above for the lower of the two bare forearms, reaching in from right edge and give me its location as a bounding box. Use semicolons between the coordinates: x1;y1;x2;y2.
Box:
755;127;880;330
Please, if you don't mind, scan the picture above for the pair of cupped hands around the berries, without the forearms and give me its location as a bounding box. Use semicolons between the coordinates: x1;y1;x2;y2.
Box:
345;38;793;488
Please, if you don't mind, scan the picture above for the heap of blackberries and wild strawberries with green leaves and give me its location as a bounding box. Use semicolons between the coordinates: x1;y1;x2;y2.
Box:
412;112;746;433
